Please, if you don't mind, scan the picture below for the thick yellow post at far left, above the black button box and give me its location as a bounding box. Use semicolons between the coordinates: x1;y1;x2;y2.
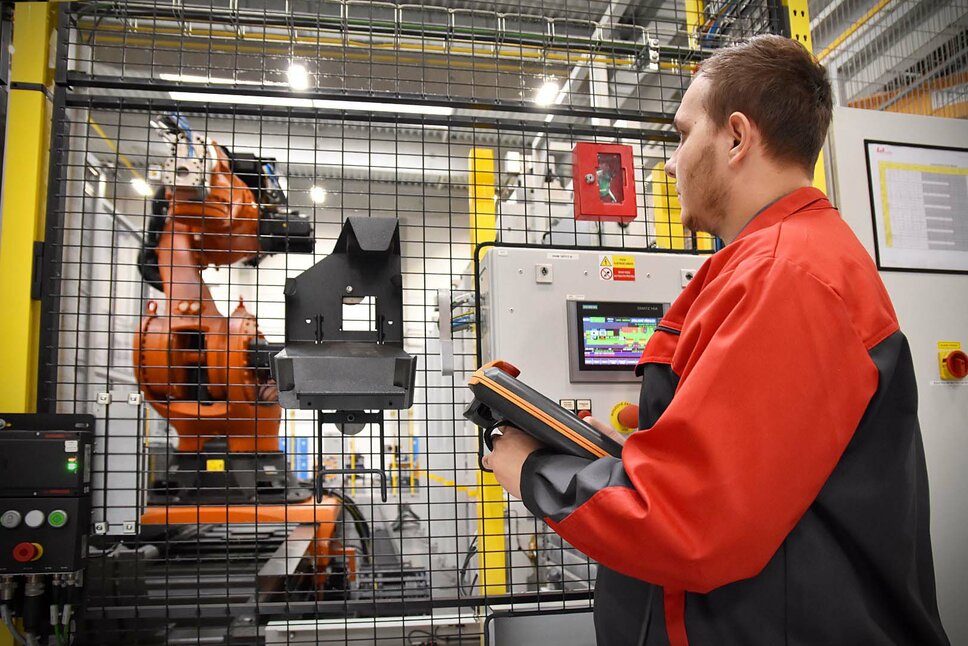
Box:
0;2;56;413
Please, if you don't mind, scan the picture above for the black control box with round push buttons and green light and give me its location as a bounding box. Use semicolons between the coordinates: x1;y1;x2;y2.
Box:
0;413;94;574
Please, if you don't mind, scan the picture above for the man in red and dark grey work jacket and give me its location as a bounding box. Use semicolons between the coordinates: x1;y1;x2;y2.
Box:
486;36;948;646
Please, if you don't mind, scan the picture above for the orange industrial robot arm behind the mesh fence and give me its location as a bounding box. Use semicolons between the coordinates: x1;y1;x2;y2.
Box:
135;121;312;453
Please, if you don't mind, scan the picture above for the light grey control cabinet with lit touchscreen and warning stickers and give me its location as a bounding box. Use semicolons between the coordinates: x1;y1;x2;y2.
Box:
478;246;706;430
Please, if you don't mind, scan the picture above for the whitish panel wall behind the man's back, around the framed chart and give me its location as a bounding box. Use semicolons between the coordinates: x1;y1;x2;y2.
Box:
831;108;968;644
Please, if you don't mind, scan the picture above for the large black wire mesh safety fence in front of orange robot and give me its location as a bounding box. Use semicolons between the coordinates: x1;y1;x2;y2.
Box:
40;0;781;644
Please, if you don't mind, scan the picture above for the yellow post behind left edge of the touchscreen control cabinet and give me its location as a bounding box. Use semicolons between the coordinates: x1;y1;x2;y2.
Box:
466;148;507;595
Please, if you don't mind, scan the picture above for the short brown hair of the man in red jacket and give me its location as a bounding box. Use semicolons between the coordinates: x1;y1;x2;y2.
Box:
699;35;833;173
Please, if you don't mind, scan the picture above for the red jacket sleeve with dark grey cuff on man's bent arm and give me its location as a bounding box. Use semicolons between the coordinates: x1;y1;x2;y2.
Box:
522;258;878;592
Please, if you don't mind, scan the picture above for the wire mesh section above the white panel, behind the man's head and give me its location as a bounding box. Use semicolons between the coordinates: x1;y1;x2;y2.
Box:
810;0;968;119
